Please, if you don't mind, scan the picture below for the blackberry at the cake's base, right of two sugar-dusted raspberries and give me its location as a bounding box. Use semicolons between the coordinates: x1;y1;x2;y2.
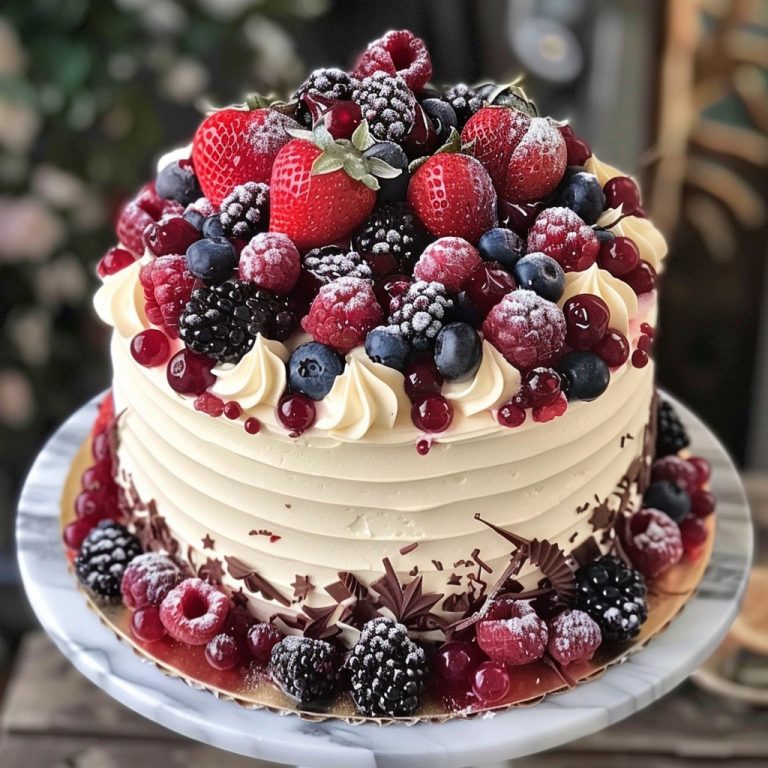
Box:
576;555;648;643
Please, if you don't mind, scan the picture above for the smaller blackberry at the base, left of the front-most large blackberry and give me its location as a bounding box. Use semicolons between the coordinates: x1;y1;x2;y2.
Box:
268;635;339;704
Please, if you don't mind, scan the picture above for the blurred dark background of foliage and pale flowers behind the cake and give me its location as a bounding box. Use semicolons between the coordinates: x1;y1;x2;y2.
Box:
0;0;768;760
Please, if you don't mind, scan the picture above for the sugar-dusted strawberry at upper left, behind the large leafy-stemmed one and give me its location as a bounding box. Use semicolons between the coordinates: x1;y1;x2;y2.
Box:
192;107;299;208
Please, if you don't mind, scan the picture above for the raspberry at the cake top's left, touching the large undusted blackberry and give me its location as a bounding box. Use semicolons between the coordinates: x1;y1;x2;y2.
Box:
139;256;198;339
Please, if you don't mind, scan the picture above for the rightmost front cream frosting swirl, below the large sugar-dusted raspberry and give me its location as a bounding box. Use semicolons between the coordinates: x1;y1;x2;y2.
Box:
443;341;520;416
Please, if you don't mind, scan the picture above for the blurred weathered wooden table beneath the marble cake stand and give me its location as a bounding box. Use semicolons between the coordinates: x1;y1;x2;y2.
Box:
0;476;768;768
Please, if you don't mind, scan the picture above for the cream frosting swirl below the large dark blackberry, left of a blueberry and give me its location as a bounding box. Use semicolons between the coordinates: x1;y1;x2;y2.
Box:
211;334;288;409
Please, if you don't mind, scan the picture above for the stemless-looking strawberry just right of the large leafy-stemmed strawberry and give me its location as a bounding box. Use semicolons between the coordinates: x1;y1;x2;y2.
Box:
408;152;497;244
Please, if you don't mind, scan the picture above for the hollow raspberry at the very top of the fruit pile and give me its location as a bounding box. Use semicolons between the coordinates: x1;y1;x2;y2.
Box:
352;29;432;91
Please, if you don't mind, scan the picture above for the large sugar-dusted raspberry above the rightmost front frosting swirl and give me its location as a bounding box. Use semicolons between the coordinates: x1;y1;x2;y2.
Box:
483;290;565;370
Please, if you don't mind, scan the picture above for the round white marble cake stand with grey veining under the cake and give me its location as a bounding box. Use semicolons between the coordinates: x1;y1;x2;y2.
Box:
16;402;752;768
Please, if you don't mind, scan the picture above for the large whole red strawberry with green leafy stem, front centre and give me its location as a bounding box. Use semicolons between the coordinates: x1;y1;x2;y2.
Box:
269;121;402;251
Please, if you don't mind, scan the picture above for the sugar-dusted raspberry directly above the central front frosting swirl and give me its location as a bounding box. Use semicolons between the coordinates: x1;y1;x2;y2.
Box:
301;277;384;354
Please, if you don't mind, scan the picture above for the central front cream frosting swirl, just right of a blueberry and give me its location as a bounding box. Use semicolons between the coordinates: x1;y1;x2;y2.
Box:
315;347;409;440
